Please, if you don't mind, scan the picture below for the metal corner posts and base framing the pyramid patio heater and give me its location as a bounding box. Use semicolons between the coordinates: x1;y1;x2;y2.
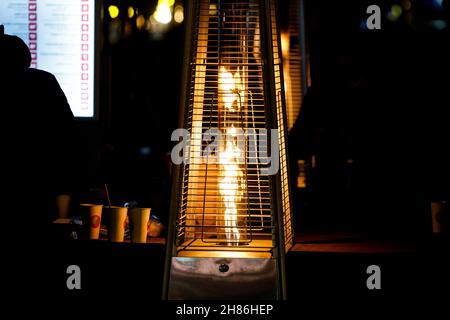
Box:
162;0;294;299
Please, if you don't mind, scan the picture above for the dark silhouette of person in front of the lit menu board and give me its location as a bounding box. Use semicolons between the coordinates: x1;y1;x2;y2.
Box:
0;29;75;222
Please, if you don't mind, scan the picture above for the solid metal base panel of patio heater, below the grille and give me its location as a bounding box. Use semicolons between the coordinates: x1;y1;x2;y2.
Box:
168;257;279;300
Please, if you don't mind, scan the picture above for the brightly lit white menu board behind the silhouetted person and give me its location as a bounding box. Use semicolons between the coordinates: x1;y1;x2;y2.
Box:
0;0;96;117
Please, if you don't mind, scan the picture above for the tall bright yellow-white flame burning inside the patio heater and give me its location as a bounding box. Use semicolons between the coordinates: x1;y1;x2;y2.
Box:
219;67;245;245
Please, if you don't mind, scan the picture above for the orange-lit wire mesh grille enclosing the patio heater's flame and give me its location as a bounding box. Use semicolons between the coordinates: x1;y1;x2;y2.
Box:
176;0;292;255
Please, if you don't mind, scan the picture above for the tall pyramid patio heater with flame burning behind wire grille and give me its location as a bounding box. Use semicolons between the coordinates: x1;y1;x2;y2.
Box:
163;0;294;299
